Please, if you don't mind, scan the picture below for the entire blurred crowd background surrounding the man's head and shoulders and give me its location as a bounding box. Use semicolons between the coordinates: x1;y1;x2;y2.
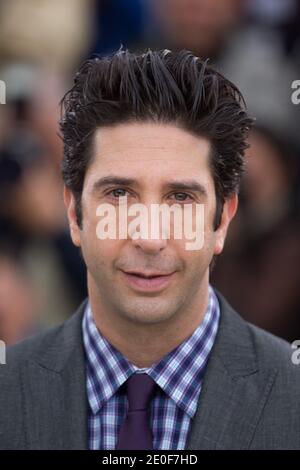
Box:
0;0;300;344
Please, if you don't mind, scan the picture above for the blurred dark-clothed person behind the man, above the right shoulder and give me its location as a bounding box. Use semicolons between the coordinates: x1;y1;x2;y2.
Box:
212;127;300;341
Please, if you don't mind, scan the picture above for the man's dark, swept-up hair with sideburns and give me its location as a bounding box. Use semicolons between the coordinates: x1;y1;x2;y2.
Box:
60;49;253;229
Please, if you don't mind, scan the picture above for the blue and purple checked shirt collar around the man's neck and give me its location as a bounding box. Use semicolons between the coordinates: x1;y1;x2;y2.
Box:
82;286;220;418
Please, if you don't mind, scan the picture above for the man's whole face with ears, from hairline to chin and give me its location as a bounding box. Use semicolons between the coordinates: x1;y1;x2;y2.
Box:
65;123;236;324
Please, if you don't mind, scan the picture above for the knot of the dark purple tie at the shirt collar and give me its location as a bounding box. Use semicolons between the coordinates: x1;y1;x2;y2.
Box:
126;374;156;411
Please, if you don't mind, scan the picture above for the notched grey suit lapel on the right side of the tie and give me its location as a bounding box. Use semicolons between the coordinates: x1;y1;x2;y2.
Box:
186;293;276;450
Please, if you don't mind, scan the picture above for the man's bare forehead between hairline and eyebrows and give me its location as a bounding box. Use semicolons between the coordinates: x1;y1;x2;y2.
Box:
86;122;211;189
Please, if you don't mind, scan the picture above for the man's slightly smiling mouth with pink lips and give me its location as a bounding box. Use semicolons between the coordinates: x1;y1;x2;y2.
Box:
122;271;175;292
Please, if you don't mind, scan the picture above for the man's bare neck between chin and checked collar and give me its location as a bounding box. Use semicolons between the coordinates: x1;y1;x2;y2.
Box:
88;276;208;367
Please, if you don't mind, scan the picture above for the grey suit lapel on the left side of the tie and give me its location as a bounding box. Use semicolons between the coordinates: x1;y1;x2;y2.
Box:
22;306;87;449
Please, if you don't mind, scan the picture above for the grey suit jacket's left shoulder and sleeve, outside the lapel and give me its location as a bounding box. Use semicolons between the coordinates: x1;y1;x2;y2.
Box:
0;304;84;449
